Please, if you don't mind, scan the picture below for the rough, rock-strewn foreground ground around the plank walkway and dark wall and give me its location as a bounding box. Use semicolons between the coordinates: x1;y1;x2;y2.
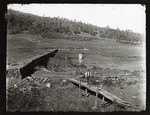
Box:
7;51;145;112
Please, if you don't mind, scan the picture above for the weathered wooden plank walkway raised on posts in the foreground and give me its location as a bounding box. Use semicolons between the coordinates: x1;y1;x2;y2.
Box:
68;78;132;107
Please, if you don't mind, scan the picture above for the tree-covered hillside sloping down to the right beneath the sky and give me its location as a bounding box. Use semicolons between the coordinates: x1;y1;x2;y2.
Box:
7;9;143;42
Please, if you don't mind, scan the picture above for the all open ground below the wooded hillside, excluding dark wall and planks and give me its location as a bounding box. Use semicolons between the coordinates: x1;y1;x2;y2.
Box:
6;35;146;112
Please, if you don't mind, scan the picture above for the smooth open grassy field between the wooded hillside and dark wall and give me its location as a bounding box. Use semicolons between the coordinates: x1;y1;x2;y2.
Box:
7;34;145;71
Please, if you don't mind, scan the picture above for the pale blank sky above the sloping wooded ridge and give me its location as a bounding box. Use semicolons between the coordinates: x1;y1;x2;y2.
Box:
7;4;146;34
